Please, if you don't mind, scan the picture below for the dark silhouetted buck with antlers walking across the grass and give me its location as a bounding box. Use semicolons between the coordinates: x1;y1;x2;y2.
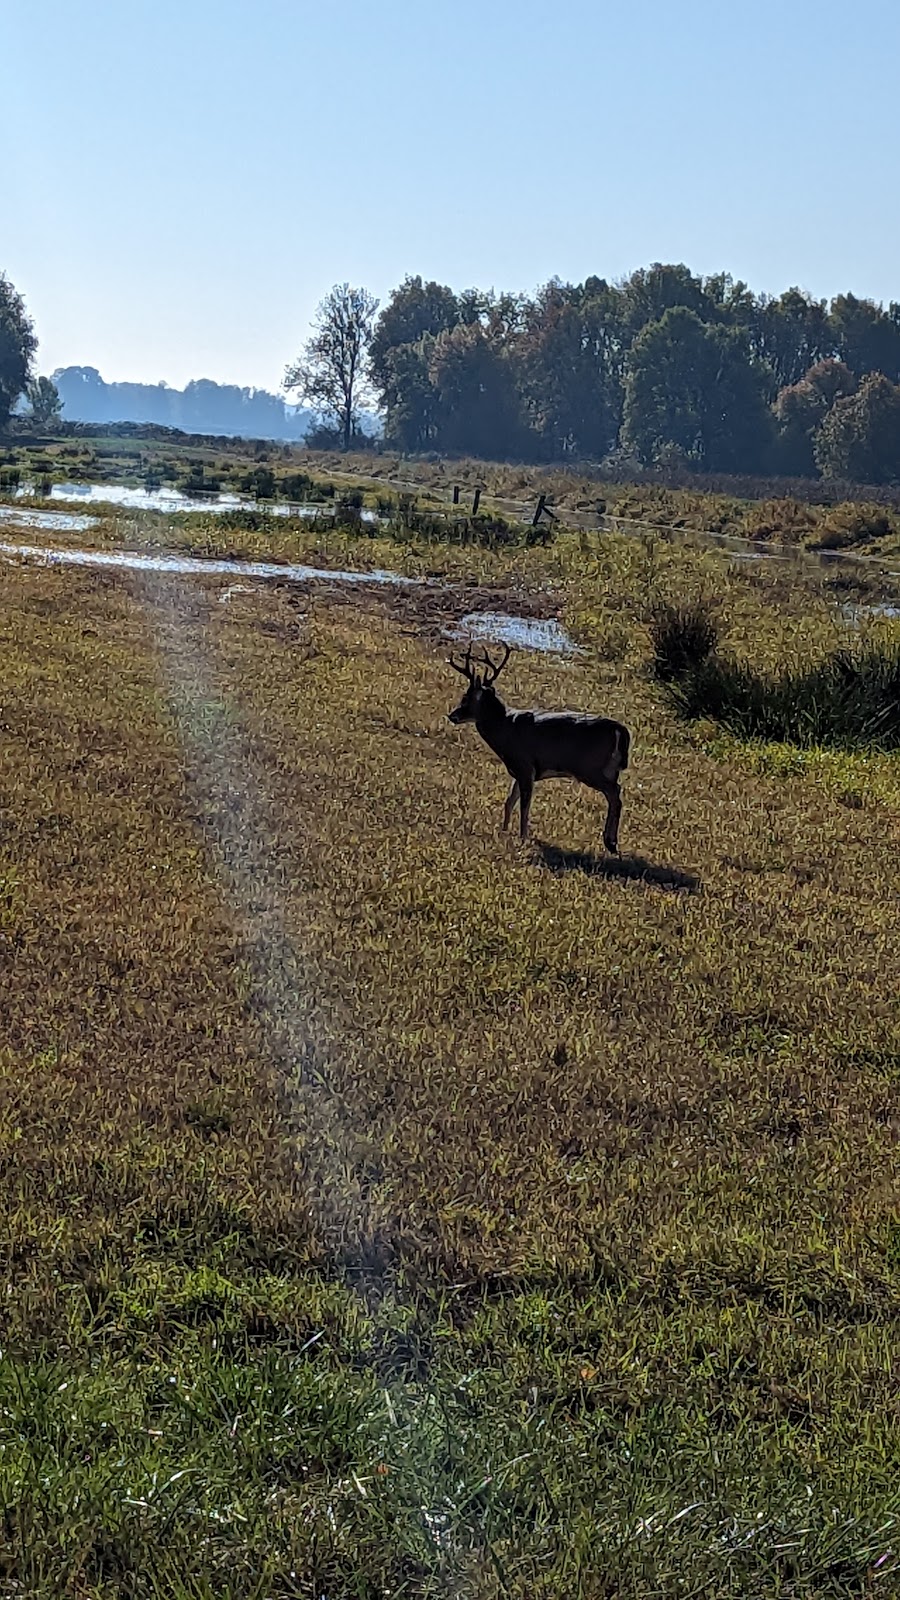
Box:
448;645;631;856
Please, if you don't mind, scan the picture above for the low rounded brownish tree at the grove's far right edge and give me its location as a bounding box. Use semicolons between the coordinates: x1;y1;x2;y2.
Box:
815;373;900;483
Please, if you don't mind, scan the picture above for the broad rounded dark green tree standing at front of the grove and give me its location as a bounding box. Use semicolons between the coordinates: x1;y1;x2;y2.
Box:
623;307;772;472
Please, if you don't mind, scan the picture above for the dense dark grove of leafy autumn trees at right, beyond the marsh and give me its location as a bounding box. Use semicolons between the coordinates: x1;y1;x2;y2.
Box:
370;264;900;483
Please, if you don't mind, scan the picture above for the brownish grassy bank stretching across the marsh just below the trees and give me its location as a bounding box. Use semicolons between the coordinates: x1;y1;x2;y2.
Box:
0;434;900;560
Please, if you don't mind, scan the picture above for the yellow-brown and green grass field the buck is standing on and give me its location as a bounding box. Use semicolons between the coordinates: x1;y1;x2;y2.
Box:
0;523;900;1600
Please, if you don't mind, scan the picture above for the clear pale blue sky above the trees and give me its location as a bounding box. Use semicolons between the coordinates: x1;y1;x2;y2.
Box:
7;0;900;387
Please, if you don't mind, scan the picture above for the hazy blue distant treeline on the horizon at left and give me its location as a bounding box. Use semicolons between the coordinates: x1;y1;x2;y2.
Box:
53;366;311;440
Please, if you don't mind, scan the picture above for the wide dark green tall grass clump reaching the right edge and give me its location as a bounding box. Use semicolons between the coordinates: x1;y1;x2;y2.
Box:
668;640;900;750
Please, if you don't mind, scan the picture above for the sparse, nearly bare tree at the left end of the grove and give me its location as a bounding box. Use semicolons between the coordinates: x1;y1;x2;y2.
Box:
285;283;378;450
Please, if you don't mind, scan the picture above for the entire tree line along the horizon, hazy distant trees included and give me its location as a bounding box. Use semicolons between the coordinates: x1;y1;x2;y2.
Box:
7;262;900;485
